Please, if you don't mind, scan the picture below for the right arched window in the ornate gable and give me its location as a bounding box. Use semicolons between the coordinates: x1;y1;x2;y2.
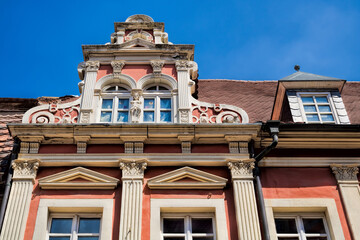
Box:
143;85;173;123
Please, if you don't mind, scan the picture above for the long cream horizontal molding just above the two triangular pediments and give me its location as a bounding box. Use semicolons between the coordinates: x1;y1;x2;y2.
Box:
19;153;249;167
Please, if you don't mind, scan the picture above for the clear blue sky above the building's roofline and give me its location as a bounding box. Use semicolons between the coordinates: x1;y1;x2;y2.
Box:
0;0;360;98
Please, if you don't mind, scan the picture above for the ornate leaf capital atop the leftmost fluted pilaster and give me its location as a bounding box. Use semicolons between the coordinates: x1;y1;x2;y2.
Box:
11;159;40;180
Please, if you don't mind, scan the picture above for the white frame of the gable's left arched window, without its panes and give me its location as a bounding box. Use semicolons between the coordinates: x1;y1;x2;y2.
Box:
97;84;132;123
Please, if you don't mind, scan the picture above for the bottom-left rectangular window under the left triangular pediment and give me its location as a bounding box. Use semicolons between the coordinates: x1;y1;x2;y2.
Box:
48;214;101;240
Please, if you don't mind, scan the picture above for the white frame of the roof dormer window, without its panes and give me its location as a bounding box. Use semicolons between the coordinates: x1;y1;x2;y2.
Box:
296;92;339;124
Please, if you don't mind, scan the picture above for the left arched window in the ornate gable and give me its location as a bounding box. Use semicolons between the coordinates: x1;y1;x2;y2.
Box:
100;85;130;123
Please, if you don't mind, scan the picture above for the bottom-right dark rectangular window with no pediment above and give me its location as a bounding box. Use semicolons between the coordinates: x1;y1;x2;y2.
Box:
275;213;330;240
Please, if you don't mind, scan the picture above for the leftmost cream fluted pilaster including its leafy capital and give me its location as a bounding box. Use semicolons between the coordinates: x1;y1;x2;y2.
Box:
0;159;39;240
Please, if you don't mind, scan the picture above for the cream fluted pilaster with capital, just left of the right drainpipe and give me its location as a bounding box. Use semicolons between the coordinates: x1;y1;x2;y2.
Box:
228;159;261;240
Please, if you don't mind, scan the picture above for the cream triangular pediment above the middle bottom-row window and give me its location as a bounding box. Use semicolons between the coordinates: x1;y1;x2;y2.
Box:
147;167;227;189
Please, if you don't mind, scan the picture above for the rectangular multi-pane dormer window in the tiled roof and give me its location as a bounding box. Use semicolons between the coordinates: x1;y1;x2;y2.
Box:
299;93;336;123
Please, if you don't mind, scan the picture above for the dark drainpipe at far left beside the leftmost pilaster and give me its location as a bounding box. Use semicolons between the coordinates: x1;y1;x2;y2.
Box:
0;138;20;229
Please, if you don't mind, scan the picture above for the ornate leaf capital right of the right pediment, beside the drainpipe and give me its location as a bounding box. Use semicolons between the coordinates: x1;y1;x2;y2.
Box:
227;159;255;180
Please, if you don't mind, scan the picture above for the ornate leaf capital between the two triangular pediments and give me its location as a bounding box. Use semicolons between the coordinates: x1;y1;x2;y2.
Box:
119;159;147;180
